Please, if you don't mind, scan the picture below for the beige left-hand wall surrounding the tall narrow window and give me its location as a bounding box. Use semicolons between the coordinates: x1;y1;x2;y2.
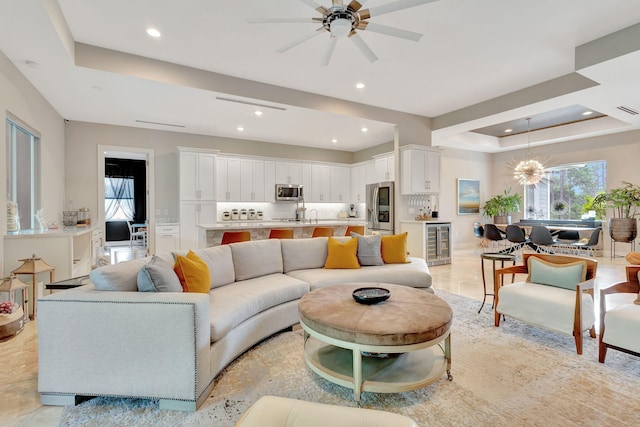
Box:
0;52;65;271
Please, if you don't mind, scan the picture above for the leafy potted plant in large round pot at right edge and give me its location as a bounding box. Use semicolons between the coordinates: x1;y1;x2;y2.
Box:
592;181;640;242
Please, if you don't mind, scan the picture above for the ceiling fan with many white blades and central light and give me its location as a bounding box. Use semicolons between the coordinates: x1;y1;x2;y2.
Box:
248;0;437;66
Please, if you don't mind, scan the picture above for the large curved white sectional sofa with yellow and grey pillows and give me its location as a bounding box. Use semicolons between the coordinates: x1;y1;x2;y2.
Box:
38;238;432;411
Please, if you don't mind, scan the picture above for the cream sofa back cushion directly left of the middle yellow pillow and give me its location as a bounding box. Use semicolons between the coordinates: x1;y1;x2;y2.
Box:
280;237;328;273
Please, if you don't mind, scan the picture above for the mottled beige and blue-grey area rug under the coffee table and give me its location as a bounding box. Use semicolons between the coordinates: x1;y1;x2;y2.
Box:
59;291;640;427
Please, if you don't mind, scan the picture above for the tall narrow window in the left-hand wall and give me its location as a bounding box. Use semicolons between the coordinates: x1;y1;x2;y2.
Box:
6;116;41;231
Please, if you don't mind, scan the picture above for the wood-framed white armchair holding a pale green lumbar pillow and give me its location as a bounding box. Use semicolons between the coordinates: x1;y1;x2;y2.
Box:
494;254;598;354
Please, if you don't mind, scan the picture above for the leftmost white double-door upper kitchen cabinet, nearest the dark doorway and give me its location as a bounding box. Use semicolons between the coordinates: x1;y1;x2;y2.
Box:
178;148;216;201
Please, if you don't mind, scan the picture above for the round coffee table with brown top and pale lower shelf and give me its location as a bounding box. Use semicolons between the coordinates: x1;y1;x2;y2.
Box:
299;283;453;401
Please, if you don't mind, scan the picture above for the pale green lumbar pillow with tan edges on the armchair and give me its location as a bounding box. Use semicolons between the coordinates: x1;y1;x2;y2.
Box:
526;257;587;290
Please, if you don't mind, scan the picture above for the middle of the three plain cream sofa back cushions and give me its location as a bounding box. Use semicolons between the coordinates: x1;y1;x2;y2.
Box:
230;239;282;281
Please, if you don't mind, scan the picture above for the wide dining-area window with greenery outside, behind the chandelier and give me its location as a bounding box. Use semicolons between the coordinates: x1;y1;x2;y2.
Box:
525;161;607;220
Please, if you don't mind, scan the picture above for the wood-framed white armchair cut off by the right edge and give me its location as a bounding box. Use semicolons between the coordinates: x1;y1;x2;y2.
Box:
598;265;640;363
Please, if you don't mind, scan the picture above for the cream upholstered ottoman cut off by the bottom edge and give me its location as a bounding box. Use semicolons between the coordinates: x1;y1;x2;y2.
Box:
236;396;418;427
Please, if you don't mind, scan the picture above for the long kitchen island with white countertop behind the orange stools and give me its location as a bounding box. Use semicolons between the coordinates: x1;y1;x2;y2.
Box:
198;218;366;248
